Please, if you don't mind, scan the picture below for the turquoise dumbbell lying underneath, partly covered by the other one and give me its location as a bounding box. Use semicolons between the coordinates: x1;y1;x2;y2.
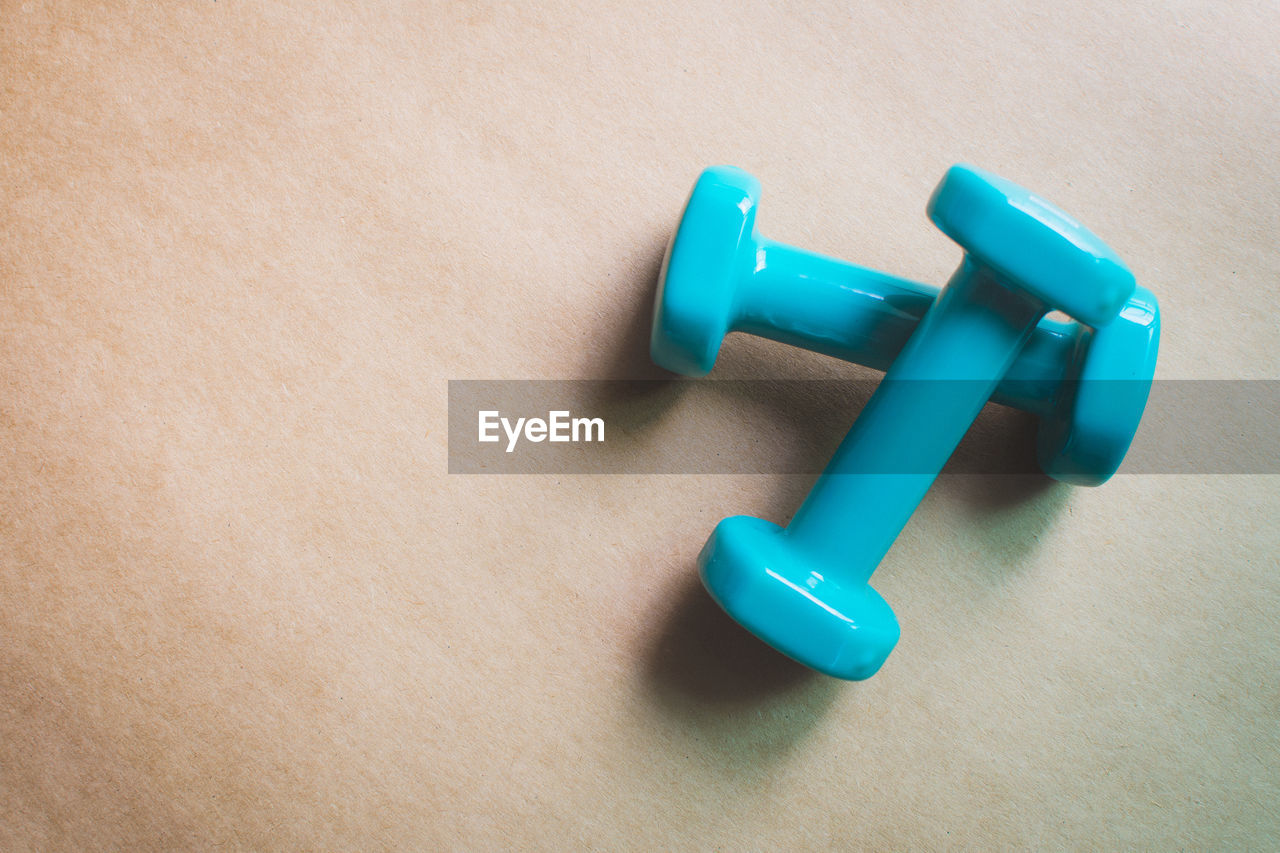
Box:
650;167;1160;485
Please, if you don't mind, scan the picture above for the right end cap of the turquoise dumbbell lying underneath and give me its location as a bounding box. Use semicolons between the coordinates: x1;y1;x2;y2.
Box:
1036;287;1160;485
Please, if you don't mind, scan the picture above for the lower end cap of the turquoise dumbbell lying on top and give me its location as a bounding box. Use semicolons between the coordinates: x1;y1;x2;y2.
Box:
698;516;900;681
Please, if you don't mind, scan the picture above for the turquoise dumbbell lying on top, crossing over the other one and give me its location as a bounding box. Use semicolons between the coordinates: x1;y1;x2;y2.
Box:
696;165;1134;679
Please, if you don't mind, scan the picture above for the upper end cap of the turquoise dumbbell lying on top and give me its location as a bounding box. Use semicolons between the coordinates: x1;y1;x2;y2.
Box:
928;164;1134;327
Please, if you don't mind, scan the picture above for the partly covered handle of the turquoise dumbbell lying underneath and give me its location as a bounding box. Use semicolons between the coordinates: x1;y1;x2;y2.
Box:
732;238;1082;416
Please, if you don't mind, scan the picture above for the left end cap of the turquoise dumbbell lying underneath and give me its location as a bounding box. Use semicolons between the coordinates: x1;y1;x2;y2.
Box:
649;167;760;377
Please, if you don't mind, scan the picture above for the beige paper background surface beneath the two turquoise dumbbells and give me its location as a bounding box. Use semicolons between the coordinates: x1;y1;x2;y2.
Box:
0;0;1280;850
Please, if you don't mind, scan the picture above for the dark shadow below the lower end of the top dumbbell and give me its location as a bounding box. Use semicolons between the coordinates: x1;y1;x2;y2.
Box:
645;571;849;749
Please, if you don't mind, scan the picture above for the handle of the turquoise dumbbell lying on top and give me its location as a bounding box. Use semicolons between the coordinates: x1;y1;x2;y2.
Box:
786;259;1047;585
